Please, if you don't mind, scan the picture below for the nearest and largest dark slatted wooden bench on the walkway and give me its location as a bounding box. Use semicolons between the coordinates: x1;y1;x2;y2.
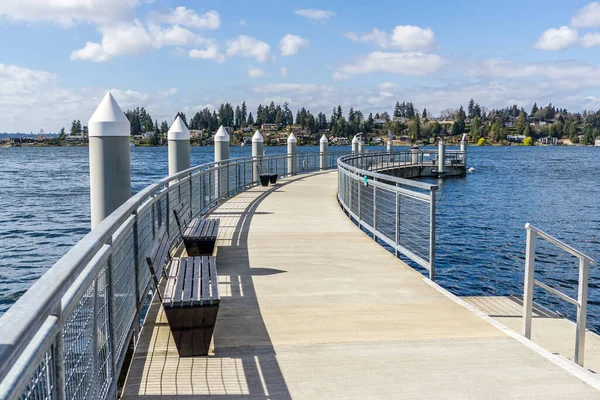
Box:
146;228;220;357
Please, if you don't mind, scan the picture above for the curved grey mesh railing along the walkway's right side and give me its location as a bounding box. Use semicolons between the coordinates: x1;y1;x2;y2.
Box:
338;151;438;280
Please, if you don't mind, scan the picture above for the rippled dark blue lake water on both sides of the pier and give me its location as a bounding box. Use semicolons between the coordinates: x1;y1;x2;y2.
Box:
0;147;600;332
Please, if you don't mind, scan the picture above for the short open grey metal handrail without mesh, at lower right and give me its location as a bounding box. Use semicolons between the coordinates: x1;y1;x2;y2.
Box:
523;224;594;366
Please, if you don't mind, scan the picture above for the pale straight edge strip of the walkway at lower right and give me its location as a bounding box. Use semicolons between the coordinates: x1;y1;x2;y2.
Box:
423;278;600;390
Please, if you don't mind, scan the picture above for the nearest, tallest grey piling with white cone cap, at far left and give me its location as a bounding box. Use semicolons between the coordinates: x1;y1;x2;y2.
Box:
88;93;131;229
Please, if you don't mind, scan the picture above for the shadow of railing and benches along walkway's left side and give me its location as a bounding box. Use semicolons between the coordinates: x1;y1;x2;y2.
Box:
122;175;324;400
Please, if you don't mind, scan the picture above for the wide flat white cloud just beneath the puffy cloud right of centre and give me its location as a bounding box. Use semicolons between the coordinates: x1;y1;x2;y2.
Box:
333;51;444;80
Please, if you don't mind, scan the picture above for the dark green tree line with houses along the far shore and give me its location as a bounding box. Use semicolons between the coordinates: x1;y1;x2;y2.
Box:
61;99;600;143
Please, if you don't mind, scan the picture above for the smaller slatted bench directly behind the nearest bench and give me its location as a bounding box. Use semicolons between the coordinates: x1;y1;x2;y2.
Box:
173;204;221;256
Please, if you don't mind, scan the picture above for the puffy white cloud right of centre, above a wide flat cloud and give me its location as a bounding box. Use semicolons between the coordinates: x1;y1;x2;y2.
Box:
345;25;435;51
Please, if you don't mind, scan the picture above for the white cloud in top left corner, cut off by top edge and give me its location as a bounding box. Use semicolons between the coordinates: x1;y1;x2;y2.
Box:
0;0;140;27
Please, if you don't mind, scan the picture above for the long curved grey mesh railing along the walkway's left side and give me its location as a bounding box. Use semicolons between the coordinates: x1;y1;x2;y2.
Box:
0;153;347;400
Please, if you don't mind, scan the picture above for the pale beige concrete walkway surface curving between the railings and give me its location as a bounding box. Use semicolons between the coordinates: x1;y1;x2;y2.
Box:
124;172;600;399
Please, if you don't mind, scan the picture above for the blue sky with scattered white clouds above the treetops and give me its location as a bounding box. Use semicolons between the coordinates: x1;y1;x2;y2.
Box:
0;0;600;132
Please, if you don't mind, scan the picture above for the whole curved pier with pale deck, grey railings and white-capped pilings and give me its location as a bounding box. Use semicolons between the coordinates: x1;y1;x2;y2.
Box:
0;95;600;400
